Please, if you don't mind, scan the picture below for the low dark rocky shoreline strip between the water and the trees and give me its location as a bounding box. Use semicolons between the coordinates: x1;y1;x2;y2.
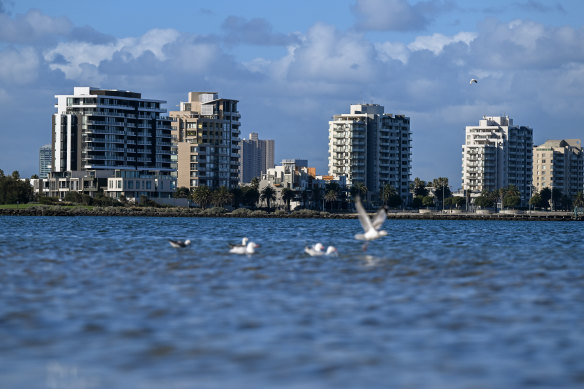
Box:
0;205;584;221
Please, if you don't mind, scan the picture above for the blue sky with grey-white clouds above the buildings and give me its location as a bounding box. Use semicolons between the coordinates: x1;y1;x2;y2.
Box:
0;0;584;190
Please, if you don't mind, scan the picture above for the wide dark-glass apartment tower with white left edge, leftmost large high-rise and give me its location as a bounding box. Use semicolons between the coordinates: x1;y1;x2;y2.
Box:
51;87;172;174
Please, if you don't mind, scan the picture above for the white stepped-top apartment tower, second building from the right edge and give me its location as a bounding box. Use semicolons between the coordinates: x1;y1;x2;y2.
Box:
462;116;533;204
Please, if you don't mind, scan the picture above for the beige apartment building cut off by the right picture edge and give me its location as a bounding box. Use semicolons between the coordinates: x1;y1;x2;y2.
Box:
533;139;584;197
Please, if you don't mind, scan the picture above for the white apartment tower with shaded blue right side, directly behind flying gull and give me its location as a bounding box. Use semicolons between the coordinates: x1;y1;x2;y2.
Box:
328;104;412;202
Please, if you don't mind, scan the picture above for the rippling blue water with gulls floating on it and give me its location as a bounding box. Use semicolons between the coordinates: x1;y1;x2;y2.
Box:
0;217;584;388
